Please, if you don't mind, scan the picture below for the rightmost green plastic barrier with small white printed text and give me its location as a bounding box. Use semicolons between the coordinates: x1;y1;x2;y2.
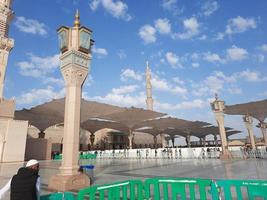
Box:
212;180;267;200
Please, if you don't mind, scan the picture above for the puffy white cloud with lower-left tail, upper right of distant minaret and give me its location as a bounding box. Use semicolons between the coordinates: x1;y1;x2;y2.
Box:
176;17;200;40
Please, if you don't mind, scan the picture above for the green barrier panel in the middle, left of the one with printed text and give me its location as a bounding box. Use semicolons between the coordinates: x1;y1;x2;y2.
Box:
145;178;212;200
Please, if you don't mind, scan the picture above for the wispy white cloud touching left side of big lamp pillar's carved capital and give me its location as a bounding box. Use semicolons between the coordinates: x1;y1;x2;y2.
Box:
17;53;59;77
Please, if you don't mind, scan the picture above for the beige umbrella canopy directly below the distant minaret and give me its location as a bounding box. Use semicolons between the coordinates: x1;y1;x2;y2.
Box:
100;107;166;129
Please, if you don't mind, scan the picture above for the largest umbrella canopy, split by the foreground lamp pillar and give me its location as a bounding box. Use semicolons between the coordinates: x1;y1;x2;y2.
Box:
15;98;124;131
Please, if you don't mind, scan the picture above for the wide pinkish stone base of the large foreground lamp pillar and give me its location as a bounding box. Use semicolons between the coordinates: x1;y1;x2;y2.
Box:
48;174;90;192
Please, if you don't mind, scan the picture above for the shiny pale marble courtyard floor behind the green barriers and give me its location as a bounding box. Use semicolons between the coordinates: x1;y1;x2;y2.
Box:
0;159;267;199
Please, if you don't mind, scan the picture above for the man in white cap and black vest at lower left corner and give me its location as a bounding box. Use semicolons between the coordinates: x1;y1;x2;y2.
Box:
0;160;41;200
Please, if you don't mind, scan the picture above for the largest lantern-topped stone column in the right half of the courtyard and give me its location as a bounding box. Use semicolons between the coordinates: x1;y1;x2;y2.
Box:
211;94;231;159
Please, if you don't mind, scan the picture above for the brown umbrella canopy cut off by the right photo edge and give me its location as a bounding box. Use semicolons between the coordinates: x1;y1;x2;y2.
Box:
224;99;267;121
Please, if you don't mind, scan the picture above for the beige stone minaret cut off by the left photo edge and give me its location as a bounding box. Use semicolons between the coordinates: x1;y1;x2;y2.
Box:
0;0;14;100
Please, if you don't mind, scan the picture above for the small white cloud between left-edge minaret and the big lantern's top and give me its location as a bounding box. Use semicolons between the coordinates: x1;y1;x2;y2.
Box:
15;17;47;36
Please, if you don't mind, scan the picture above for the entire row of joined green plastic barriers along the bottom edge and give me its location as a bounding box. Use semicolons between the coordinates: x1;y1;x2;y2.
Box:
41;178;267;200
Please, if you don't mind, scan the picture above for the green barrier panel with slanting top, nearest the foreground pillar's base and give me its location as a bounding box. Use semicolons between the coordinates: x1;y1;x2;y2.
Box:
78;180;144;200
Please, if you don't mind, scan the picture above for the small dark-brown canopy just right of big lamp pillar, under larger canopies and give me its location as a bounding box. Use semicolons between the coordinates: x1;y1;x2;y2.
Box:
81;119;128;133
